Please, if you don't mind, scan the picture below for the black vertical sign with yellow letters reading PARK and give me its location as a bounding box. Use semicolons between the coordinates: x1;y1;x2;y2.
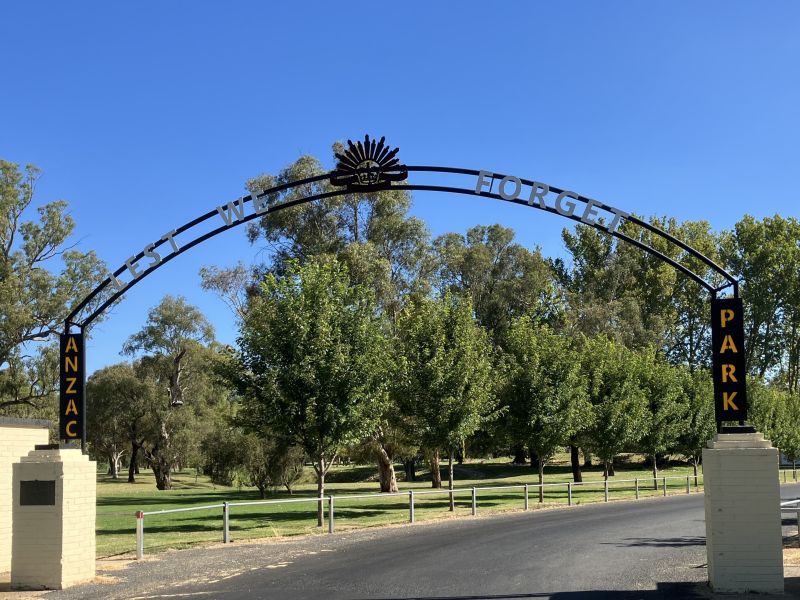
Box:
711;298;747;423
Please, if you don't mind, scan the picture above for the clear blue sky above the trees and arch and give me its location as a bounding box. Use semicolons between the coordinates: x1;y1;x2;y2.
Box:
0;0;800;372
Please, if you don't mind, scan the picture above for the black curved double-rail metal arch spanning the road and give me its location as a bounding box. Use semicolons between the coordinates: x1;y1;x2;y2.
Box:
65;165;738;331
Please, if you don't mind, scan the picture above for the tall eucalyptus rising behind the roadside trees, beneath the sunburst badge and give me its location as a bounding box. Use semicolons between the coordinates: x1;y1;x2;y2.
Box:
201;144;433;491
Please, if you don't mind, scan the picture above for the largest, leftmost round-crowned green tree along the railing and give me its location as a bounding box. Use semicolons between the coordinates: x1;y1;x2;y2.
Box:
226;258;388;526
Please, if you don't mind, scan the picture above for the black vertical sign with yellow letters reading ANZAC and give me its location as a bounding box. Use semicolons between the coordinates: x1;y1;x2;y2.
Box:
58;333;86;441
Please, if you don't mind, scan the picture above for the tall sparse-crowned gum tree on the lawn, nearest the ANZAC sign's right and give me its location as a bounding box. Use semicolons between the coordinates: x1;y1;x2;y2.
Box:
123;295;214;490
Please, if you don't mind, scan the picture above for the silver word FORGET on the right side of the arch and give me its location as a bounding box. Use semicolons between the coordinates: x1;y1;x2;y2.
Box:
475;171;630;233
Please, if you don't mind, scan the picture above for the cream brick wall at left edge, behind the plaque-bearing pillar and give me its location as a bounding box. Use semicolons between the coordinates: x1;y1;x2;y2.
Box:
0;417;50;573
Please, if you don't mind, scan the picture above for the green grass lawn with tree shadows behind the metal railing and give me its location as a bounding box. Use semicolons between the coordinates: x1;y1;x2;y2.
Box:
97;455;702;557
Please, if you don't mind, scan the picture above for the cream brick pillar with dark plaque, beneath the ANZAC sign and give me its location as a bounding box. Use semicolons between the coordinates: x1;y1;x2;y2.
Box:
11;447;97;589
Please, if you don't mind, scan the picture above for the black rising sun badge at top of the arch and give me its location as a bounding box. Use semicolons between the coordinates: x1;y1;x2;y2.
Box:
331;135;408;191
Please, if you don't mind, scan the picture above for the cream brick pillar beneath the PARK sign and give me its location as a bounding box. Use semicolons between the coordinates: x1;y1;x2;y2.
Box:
703;433;783;593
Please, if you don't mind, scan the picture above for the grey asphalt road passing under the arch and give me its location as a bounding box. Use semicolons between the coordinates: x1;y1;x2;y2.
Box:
43;485;800;600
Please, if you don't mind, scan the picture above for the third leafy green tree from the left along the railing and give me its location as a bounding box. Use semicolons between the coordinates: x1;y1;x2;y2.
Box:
503;317;591;502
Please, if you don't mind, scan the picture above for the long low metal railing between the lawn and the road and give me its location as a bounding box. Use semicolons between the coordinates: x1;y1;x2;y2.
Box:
135;475;702;560
